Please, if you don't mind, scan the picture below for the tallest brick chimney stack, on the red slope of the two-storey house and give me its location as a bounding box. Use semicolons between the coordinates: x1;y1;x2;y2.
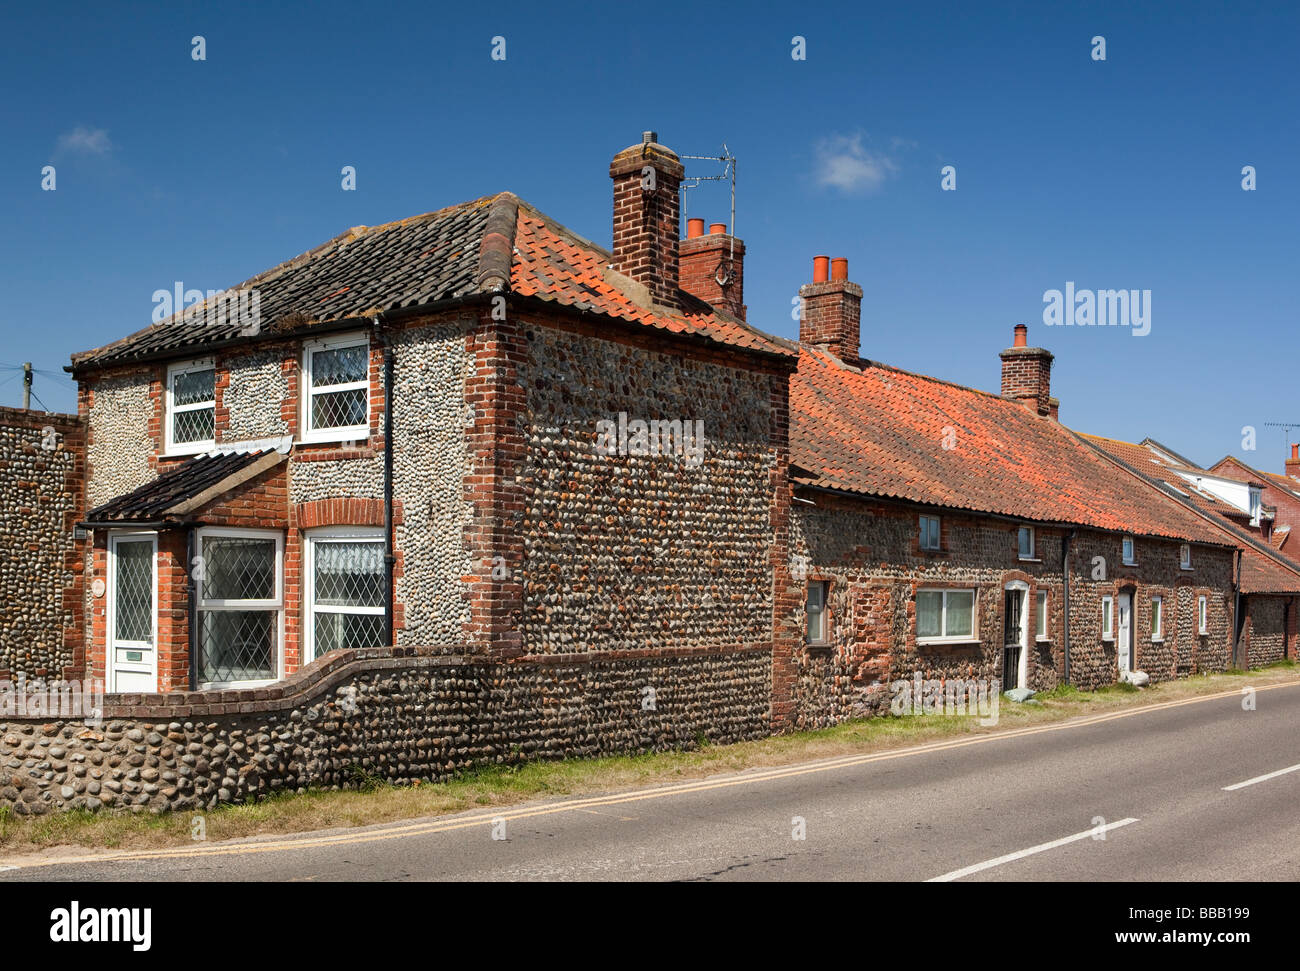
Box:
610;131;685;307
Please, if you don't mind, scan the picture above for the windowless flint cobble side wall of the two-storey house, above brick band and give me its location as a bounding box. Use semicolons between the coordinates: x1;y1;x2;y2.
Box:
519;321;777;654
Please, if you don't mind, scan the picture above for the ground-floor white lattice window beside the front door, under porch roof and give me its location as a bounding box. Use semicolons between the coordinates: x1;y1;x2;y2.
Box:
192;526;285;688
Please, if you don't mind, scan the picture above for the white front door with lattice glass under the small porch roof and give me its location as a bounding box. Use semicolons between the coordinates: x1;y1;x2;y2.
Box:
108;533;159;692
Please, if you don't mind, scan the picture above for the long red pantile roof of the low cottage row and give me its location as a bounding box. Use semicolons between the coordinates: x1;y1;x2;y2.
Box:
790;348;1231;546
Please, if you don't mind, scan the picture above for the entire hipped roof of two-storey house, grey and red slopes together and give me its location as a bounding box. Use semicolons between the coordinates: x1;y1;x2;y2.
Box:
73;192;797;370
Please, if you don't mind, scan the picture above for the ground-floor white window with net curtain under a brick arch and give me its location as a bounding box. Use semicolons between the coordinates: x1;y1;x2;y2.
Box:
303;526;387;664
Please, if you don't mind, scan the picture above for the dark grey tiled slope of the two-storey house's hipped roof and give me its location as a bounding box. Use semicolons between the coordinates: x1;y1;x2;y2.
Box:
73;192;496;368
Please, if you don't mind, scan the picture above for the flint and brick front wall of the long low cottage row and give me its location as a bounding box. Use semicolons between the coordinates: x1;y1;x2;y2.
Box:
790;490;1237;728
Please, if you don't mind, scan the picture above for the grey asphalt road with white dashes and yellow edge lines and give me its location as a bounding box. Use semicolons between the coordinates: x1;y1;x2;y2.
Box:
0;684;1300;881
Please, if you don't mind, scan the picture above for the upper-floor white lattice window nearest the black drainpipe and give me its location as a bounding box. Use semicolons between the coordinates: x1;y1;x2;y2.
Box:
302;334;371;442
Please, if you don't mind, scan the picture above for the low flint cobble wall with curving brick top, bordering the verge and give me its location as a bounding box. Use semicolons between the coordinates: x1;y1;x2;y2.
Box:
0;647;772;815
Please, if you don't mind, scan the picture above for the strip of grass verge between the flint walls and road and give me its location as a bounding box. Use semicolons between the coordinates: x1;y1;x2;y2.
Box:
0;660;1300;862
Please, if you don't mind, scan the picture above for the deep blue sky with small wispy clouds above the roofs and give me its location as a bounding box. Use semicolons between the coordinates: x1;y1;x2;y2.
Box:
0;3;1300;472
